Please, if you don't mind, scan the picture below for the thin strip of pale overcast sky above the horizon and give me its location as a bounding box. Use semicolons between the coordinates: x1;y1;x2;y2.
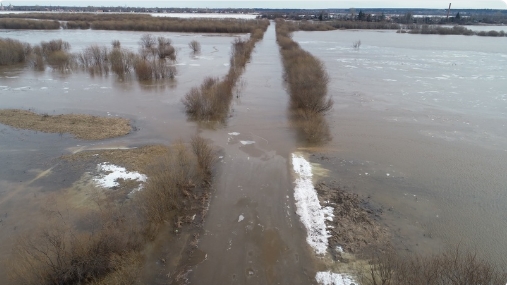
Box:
0;0;507;9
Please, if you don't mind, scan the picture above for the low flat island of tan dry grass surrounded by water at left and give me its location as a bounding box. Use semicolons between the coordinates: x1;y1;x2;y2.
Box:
0;109;131;140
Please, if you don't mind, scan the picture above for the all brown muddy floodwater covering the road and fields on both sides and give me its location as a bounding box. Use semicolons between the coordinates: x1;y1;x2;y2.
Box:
0;23;507;284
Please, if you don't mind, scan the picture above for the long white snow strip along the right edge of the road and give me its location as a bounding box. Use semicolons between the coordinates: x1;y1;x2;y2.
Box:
292;153;333;255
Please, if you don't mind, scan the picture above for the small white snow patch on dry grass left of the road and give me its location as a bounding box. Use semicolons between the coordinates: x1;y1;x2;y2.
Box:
93;162;146;190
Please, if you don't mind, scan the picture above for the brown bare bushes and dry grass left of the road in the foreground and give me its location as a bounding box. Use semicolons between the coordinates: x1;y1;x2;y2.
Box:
9;137;216;285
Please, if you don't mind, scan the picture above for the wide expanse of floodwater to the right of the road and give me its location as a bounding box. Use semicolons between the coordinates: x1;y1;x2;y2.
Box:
294;28;507;262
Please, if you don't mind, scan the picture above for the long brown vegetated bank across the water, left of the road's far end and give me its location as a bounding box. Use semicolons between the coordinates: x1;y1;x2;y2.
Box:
0;13;268;33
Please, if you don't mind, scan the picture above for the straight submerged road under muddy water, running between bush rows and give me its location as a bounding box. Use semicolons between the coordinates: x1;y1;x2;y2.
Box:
189;23;316;284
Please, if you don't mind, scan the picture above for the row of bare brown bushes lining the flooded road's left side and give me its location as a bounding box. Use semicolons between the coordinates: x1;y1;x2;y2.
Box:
183;21;269;122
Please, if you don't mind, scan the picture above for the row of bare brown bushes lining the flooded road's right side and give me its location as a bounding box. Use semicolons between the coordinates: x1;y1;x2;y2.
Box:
276;20;333;143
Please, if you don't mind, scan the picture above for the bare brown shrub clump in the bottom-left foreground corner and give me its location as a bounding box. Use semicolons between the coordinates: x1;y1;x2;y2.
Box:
10;207;144;285
